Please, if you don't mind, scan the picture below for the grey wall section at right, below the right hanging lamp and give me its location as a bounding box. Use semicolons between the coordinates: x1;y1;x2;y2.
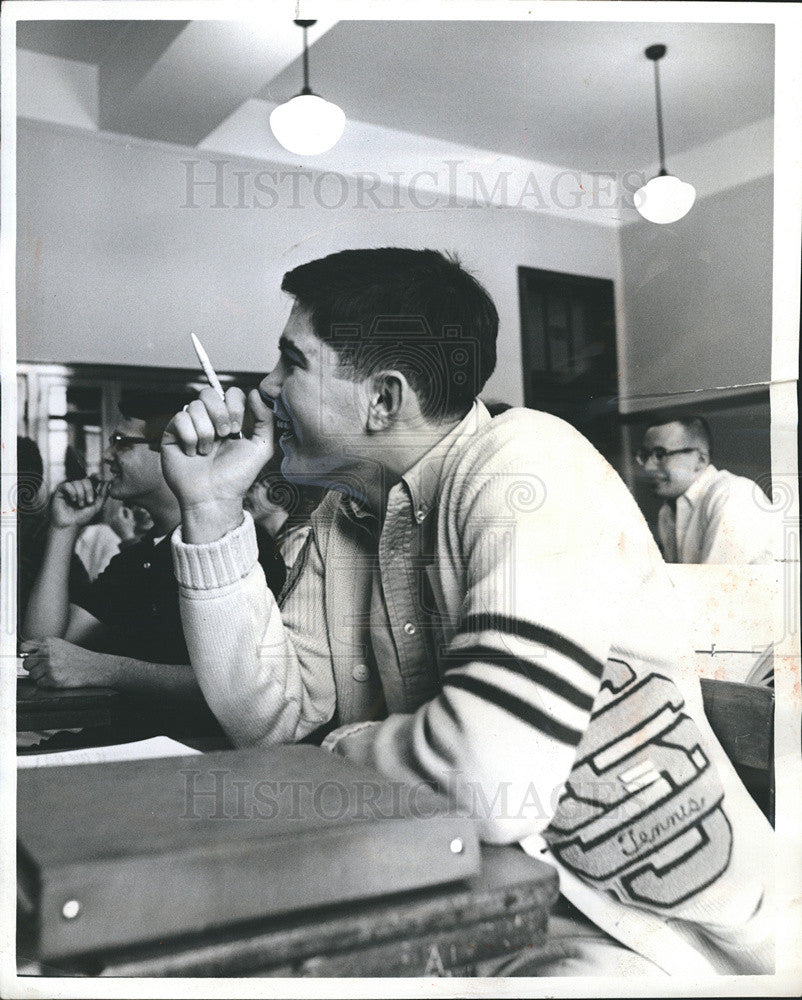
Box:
621;176;773;410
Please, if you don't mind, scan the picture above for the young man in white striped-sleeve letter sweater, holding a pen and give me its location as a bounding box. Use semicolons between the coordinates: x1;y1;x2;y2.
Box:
162;249;773;975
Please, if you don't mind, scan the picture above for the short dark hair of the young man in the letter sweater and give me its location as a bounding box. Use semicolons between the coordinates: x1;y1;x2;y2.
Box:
281;247;498;419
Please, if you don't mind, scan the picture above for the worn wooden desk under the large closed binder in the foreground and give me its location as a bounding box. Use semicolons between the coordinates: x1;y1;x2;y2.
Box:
23;846;559;977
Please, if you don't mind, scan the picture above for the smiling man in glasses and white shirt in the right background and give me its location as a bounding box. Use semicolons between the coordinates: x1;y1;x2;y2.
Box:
635;416;772;564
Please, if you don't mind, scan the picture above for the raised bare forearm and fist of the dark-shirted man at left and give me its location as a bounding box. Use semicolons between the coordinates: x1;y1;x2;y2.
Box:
22;479;108;644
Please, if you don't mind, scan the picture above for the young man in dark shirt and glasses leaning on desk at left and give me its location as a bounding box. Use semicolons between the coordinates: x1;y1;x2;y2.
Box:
21;392;284;700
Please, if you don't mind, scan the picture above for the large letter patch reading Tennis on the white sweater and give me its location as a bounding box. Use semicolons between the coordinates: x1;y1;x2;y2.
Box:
544;660;732;908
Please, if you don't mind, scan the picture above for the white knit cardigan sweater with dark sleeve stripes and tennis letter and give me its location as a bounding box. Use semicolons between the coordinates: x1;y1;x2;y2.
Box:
173;403;773;974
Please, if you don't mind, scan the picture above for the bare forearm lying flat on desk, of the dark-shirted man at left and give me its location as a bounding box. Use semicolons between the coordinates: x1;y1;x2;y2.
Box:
20;637;202;701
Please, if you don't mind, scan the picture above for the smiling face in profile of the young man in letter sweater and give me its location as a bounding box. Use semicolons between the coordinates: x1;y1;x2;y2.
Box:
259;303;368;486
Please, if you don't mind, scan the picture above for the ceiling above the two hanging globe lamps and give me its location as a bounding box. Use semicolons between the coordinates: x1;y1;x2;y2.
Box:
17;20;774;171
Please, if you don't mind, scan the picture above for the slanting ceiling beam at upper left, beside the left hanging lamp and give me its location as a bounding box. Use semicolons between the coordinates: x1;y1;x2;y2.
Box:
98;18;336;146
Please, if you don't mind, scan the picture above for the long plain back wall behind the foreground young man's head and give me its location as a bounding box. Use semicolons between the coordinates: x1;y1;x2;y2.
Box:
17;119;619;404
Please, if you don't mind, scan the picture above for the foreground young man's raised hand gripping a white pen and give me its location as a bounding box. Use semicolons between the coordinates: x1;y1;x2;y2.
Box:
161;388;273;543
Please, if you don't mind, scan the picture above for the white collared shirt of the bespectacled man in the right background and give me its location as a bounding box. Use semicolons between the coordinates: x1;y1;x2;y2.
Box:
657;465;773;564
